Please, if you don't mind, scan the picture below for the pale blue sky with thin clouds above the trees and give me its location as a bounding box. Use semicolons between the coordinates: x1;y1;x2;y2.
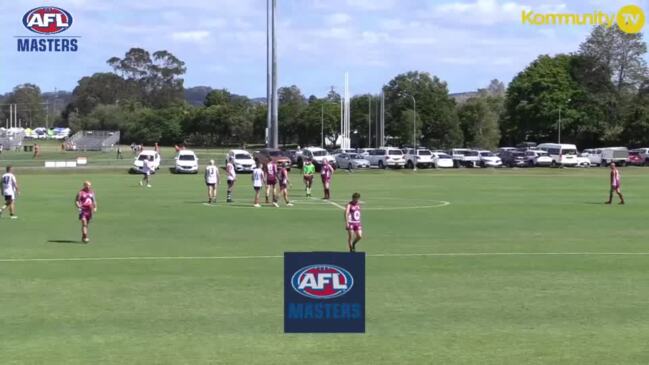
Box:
0;0;649;97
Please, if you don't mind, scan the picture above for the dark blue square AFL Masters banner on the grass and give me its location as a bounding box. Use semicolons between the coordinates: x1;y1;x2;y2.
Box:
284;252;365;333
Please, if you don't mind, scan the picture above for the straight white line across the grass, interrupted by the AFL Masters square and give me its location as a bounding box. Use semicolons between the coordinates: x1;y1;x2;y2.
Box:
0;252;649;262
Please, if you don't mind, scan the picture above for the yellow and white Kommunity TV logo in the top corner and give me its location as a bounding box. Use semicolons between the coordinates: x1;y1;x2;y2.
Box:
521;5;645;33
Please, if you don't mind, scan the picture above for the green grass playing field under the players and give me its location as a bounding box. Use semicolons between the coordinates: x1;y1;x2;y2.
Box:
0;168;649;365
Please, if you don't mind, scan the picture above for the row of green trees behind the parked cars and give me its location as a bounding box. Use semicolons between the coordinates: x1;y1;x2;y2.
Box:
0;26;649;149
